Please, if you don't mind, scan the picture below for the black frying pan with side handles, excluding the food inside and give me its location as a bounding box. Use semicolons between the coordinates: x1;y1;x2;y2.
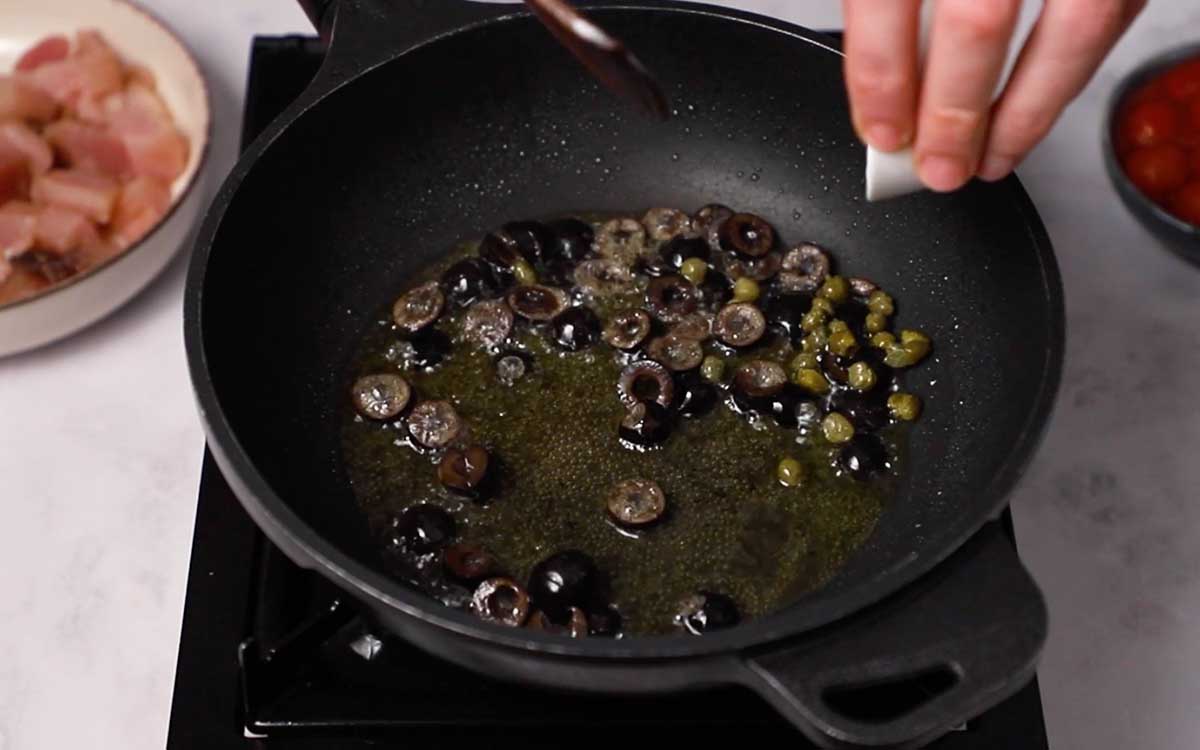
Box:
185;0;1063;748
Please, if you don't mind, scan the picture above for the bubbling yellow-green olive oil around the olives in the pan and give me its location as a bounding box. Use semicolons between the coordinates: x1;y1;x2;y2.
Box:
343;232;902;635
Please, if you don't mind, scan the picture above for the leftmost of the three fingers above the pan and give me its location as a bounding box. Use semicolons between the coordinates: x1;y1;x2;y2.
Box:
844;0;920;151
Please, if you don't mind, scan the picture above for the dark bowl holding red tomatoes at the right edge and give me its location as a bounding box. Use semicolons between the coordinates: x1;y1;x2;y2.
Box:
1103;42;1200;265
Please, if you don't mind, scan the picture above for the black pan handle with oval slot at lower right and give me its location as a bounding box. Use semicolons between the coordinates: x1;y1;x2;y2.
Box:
743;522;1046;750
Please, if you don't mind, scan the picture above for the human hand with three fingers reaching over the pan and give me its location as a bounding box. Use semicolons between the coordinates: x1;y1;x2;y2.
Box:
844;0;1146;191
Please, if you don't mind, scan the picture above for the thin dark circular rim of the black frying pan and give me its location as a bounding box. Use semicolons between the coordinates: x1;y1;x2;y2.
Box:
184;1;1066;661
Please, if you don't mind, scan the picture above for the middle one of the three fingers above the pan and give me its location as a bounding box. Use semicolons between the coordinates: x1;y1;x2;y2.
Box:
916;0;1021;191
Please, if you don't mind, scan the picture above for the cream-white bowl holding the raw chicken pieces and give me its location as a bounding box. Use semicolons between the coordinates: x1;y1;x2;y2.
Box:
0;0;211;356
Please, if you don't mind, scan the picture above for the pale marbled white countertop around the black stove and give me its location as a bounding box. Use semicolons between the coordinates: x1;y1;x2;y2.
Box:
0;0;1200;750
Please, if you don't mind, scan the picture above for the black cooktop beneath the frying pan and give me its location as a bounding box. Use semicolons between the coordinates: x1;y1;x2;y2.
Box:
167;36;1049;750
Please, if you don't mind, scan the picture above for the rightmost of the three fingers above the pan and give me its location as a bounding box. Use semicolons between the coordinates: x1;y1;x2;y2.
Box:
979;0;1145;180
